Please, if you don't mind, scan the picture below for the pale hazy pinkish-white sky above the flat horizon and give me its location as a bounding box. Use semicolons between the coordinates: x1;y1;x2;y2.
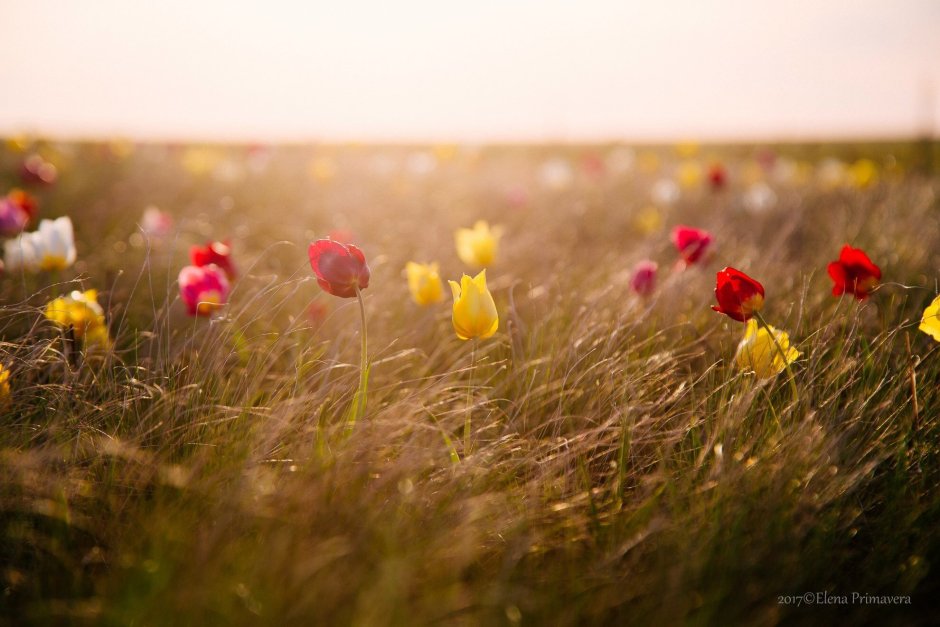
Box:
0;0;940;142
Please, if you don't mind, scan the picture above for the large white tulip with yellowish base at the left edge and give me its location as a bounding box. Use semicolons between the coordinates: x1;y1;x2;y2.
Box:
4;217;77;272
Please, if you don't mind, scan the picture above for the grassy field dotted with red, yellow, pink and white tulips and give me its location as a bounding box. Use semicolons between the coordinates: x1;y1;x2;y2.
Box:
0;138;940;626
